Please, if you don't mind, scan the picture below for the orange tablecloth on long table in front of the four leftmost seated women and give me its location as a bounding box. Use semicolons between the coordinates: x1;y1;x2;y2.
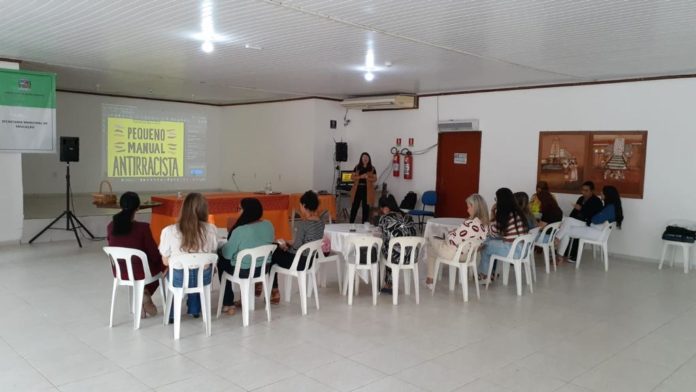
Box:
150;192;292;244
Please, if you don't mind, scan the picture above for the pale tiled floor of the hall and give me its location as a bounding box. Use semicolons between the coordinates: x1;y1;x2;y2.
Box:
0;242;696;392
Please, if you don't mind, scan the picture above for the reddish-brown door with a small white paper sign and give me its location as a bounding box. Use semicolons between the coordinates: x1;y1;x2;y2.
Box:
435;131;481;218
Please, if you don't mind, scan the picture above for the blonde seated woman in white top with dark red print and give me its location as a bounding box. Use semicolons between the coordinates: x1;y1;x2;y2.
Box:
425;193;489;289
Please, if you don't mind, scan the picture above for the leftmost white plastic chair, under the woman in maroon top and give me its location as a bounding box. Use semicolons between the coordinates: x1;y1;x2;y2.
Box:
103;246;165;329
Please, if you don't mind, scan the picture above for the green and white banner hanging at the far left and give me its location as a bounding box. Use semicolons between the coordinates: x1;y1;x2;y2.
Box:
0;69;56;153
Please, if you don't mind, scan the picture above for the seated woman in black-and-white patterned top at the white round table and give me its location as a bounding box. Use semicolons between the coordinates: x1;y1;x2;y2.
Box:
378;195;416;293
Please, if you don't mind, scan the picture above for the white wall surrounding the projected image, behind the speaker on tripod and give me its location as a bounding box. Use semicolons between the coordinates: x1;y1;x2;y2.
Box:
22;92;222;194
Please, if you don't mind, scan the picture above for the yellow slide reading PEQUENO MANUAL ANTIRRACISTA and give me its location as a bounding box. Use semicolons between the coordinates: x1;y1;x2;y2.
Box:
106;117;184;178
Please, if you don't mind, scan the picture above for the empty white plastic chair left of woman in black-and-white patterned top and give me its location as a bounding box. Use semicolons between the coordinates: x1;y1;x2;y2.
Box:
344;236;383;305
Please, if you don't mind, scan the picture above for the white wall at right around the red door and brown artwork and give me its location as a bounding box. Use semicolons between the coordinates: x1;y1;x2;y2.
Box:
348;79;696;259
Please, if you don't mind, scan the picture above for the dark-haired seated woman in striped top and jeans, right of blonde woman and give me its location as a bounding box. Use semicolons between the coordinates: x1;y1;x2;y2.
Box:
479;188;529;283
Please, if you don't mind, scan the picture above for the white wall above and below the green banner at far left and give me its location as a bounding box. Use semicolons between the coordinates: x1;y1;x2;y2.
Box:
0;61;24;244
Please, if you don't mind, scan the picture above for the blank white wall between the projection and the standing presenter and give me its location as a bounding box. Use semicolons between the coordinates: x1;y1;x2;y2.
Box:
221;99;341;192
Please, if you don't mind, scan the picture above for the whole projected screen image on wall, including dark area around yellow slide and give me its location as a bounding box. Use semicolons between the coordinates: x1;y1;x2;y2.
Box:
102;104;207;182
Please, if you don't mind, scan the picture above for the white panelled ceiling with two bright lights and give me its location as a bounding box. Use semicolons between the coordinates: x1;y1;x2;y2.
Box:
0;0;696;104
